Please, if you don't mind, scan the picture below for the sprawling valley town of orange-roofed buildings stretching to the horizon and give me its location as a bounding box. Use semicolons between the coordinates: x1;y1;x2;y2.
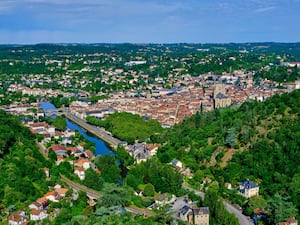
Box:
0;44;300;225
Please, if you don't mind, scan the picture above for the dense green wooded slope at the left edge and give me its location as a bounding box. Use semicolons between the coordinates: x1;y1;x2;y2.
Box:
0;110;49;220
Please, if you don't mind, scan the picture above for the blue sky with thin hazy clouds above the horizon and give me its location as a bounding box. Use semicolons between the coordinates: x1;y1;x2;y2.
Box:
0;0;300;44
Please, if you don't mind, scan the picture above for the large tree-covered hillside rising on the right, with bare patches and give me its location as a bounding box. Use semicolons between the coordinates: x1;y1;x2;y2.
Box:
158;90;300;220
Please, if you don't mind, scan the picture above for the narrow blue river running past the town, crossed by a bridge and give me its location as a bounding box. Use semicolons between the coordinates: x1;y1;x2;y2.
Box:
40;102;115;156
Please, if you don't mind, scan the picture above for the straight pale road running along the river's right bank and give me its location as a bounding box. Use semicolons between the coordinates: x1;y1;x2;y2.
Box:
64;111;121;149
